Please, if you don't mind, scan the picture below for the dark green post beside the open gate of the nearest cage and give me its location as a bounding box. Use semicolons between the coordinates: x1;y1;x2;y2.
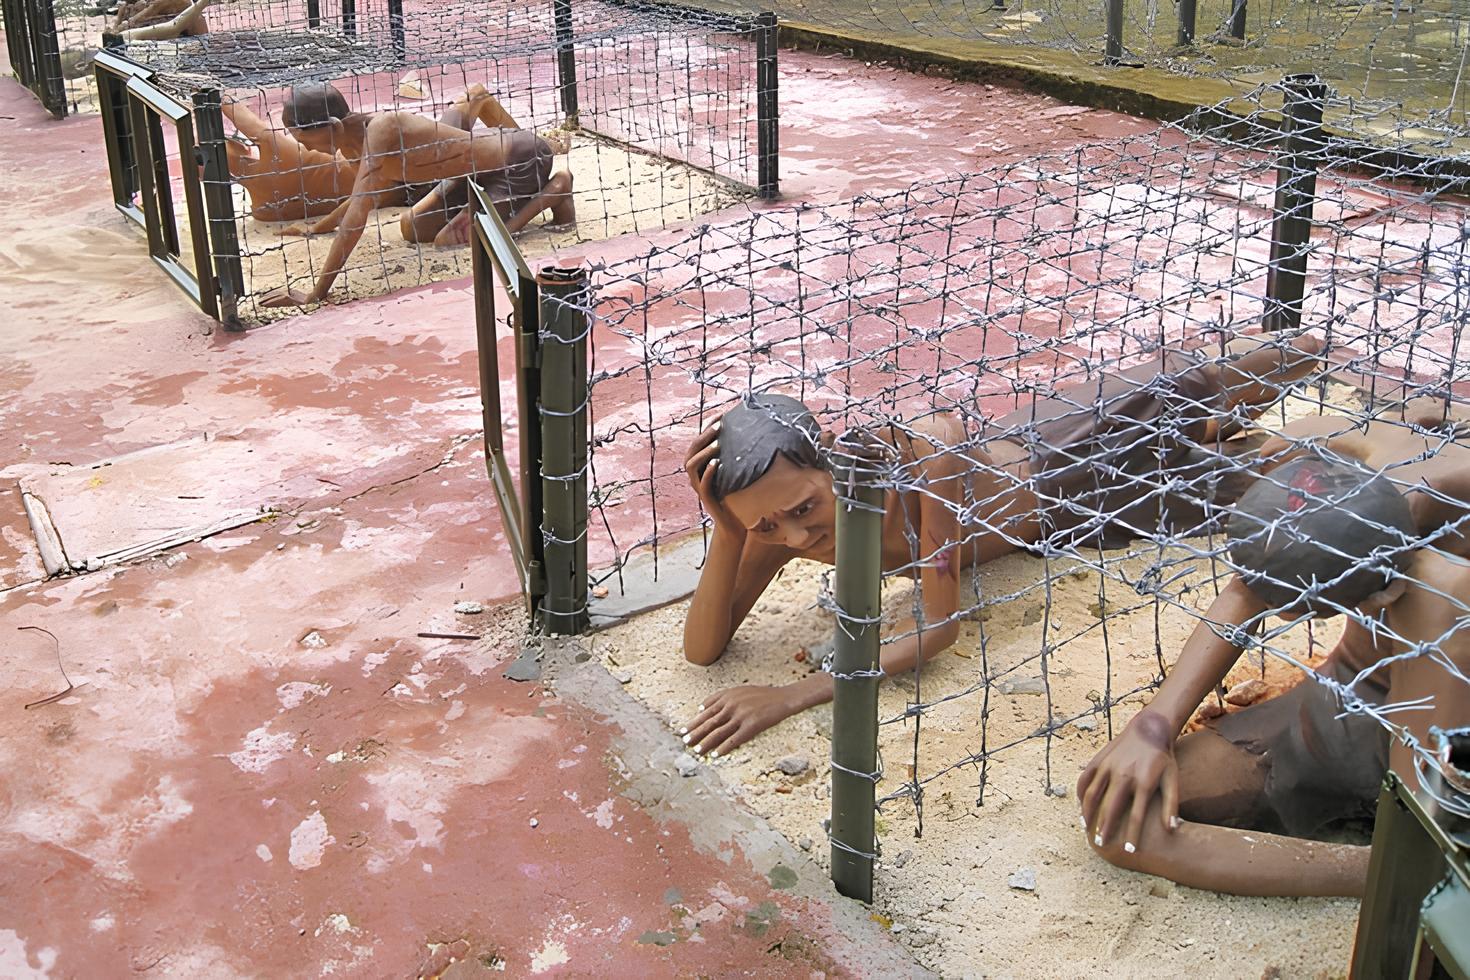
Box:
532;266;591;633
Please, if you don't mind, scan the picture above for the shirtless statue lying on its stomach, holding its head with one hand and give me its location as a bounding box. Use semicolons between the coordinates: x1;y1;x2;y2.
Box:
681;336;1320;757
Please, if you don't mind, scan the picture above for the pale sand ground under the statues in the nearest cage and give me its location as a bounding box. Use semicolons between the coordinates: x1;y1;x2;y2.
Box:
592;388;1358;979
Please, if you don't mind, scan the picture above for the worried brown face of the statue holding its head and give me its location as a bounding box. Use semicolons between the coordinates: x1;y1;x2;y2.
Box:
723;455;836;554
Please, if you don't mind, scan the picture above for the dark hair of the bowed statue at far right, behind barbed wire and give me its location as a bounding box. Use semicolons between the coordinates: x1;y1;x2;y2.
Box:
1226;458;1417;611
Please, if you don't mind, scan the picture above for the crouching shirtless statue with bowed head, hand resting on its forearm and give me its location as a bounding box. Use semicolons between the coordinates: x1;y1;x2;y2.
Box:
1078;414;1470;896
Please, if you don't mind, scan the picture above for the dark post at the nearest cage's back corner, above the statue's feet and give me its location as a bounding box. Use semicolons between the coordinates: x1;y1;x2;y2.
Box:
1264;75;1327;331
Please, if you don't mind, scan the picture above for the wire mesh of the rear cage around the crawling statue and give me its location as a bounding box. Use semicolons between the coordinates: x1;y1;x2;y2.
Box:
81;0;759;320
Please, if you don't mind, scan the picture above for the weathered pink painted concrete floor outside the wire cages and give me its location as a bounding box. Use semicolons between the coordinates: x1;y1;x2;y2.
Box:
0;44;1228;977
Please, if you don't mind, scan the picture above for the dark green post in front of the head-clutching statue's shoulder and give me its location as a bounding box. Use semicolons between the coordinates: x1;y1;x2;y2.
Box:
831;444;883;902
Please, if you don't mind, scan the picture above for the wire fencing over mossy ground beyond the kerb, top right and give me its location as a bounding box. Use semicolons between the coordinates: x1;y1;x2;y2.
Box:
720;0;1470;151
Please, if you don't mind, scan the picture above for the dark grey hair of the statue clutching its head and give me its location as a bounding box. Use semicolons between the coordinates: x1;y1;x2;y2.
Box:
714;395;822;500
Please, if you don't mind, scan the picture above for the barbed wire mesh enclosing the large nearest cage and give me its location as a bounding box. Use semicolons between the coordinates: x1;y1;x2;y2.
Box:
558;79;1470;893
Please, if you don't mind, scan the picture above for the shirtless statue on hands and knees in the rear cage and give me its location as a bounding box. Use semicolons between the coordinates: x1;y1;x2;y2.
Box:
262;82;575;307
